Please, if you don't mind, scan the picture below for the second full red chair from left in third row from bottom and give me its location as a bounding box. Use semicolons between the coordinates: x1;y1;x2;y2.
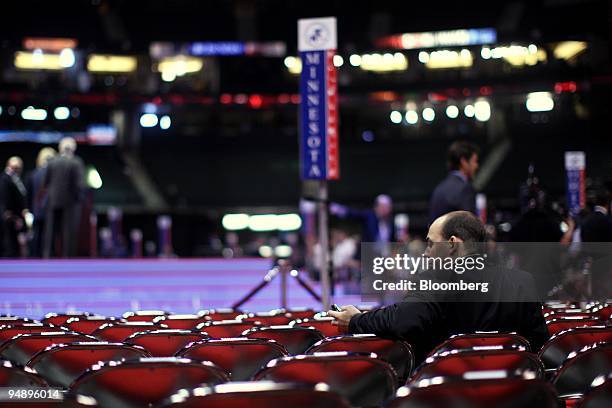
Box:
177;338;288;381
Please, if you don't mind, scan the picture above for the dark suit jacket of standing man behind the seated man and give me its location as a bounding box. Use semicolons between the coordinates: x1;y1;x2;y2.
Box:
429;172;476;223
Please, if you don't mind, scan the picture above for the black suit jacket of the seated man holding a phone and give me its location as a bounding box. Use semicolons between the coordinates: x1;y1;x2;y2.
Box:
349;266;549;362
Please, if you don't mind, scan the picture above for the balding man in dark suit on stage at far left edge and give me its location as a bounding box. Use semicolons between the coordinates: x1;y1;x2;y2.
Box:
0;156;27;258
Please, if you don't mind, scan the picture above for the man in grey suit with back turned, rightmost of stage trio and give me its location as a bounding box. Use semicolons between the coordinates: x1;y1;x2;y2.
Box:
43;137;85;258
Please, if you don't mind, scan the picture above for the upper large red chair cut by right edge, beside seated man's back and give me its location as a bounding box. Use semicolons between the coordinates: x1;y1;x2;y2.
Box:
539;326;612;369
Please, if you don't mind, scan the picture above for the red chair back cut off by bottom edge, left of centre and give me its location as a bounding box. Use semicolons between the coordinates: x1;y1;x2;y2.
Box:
159;381;350;408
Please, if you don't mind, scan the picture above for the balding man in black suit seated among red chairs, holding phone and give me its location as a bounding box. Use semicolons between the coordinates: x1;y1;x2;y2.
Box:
328;211;548;363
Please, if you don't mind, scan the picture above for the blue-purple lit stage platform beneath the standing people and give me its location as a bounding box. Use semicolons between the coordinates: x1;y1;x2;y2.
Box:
0;258;362;319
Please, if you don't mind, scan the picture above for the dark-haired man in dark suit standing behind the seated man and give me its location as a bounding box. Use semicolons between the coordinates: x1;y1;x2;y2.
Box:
429;141;480;223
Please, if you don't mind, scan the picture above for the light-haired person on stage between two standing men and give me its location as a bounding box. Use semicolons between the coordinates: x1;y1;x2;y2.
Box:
26;147;56;258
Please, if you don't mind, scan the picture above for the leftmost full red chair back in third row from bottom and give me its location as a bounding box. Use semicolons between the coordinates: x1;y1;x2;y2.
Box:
28;342;149;387
